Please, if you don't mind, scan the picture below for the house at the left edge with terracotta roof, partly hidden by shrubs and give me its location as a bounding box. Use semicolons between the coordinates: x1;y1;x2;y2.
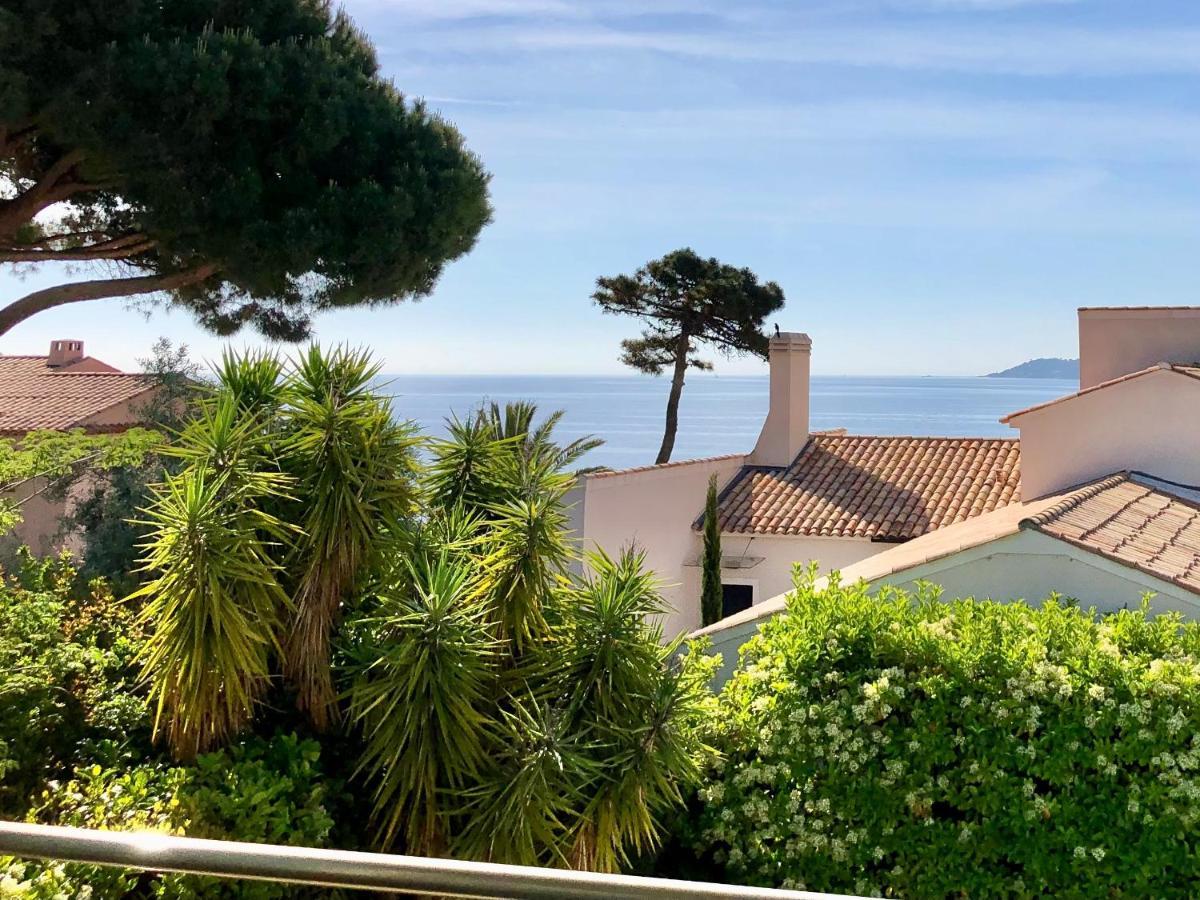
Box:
0;340;157;552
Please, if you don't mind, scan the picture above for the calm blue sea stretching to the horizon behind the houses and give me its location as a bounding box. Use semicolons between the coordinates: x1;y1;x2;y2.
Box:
382;374;1078;469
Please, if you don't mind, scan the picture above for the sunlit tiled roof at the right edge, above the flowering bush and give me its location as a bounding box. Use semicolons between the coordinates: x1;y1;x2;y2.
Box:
1021;473;1200;593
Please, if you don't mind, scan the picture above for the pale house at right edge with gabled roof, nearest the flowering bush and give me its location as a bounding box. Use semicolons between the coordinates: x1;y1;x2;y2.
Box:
698;307;1200;666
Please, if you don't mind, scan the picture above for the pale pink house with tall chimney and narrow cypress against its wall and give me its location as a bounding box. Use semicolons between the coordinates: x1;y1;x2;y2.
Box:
571;332;1020;635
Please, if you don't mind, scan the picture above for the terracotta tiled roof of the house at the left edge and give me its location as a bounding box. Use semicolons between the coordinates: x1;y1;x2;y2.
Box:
0;356;150;437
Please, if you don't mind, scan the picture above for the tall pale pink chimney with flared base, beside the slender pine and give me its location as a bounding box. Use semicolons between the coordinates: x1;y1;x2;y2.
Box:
746;331;812;467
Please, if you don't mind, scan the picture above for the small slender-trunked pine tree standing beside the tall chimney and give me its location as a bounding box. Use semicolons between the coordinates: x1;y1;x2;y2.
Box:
592;247;784;463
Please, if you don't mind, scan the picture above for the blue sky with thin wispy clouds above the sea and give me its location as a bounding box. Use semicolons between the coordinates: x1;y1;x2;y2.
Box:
0;0;1200;374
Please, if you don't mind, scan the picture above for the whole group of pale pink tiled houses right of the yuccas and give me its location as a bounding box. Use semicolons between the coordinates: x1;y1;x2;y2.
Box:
575;307;1200;646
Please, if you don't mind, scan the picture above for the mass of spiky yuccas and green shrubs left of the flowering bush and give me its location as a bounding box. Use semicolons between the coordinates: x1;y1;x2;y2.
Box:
0;348;713;898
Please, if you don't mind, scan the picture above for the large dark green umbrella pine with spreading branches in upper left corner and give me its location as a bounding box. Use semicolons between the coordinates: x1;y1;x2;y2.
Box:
0;0;491;340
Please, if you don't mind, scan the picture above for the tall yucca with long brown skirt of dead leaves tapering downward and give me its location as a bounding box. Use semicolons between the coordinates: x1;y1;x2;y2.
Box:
284;346;418;730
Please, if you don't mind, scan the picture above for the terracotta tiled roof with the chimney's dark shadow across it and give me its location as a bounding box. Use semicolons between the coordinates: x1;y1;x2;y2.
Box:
720;434;1020;541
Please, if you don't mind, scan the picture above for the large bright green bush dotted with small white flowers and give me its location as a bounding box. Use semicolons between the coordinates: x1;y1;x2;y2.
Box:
686;574;1200;898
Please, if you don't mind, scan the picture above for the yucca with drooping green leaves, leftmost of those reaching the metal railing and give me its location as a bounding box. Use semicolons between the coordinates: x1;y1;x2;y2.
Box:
349;551;499;856
